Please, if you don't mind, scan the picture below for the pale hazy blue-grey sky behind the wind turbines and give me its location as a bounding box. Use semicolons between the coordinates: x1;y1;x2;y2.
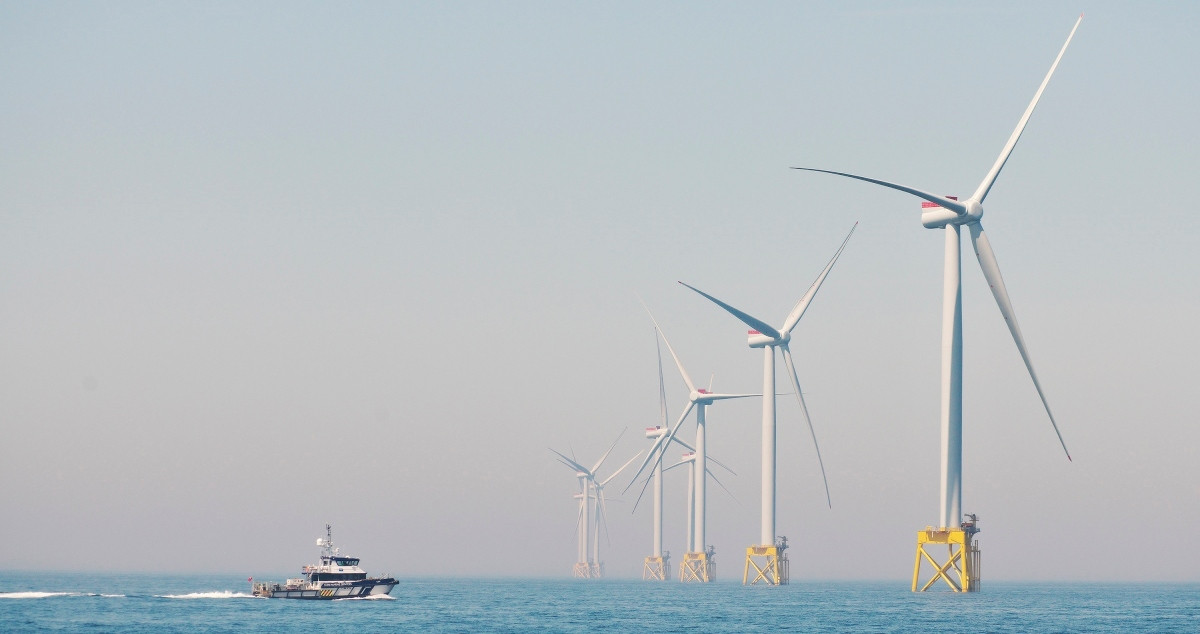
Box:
0;1;1200;580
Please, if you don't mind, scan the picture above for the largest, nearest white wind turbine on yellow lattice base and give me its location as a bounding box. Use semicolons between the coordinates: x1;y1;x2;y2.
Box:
794;14;1084;592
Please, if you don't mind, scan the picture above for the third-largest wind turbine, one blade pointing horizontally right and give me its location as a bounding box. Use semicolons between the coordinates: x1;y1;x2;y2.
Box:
646;309;761;581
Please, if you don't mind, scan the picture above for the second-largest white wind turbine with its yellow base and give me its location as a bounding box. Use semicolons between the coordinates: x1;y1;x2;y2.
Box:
681;222;858;585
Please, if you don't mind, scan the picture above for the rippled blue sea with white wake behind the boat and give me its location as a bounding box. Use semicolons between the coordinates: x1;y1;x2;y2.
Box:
0;573;1200;633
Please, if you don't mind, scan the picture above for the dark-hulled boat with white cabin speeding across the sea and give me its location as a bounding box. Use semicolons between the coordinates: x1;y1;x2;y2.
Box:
251;524;397;599
